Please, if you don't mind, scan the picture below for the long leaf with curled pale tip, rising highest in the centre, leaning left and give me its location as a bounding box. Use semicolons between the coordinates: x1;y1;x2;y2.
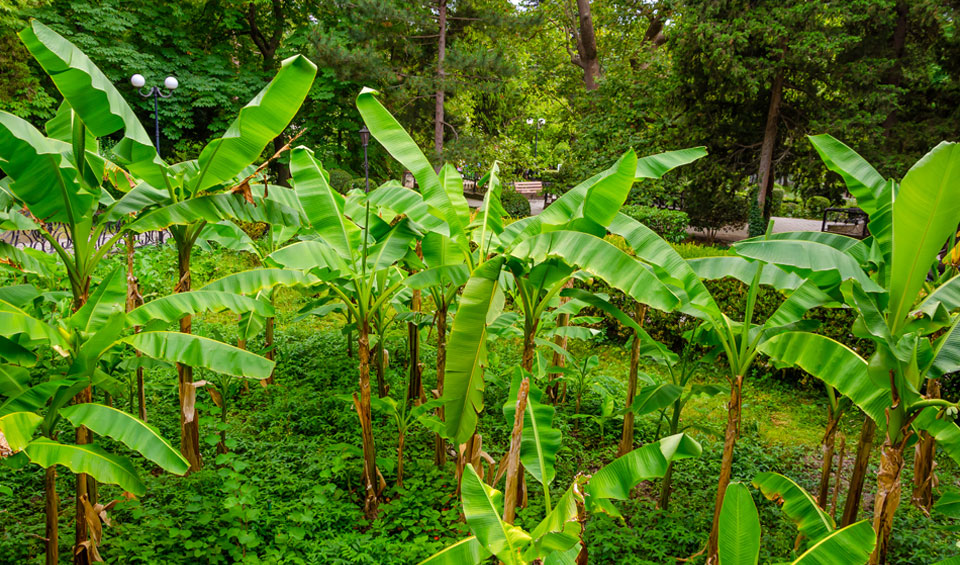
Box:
357;88;469;240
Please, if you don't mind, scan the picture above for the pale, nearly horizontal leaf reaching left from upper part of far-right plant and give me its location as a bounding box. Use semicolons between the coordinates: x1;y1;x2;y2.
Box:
734;240;883;293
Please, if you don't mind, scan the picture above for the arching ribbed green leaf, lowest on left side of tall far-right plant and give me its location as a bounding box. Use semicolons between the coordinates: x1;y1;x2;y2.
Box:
758;332;891;429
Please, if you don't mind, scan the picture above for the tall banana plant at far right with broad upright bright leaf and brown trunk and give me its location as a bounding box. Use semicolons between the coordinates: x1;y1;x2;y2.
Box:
736;135;960;563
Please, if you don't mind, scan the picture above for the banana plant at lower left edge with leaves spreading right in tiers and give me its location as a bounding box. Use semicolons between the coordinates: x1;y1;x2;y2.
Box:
0;267;273;563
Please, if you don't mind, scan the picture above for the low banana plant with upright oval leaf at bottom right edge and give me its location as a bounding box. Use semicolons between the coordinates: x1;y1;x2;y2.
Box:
719;473;876;565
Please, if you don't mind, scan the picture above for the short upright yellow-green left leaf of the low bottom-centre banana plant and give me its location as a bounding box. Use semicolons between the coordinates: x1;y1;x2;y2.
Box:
461;463;530;565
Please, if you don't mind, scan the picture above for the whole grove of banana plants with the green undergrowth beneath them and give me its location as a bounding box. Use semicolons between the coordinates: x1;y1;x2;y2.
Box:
0;20;960;565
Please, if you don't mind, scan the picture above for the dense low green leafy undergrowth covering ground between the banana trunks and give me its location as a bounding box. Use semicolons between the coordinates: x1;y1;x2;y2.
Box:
0;245;958;564
